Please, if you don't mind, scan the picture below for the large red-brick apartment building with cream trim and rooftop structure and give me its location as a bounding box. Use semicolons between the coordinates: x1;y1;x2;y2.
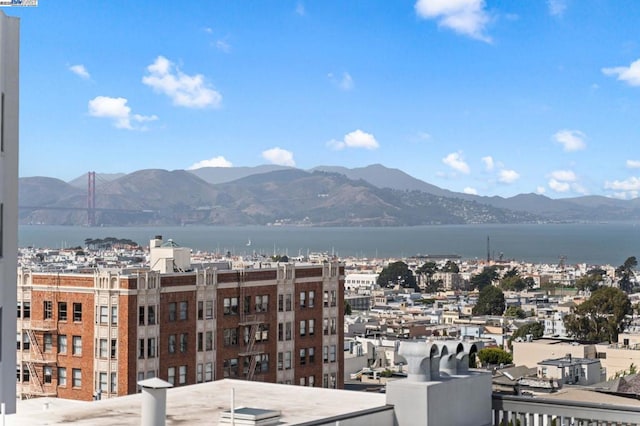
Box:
17;239;344;400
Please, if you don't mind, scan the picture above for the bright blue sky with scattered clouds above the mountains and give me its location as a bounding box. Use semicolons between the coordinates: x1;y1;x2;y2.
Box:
4;0;640;199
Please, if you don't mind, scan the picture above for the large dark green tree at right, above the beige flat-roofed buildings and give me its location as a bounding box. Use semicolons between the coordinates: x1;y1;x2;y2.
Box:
564;287;633;342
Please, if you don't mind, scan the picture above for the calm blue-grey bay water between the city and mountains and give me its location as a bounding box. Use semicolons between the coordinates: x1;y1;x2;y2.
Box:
18;222;640;266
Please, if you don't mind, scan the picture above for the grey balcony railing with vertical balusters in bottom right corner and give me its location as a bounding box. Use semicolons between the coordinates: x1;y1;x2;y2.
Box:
491;393;640;426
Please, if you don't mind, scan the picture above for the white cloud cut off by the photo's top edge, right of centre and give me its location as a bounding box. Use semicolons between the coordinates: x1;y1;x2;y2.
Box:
415;0;491;42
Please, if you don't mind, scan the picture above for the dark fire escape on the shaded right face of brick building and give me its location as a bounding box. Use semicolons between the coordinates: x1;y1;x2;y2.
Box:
238;271;265;380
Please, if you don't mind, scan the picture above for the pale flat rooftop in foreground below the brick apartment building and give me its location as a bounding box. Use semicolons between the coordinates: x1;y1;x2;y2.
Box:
6;379;387;426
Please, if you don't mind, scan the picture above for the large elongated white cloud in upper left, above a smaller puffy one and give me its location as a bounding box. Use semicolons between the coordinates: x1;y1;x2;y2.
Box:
142;56;222;108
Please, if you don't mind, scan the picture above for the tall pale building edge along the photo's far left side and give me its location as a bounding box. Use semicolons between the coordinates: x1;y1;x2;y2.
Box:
0;12;20;413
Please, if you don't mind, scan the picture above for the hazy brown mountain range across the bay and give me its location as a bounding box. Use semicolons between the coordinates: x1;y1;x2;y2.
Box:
19;164;640;226
